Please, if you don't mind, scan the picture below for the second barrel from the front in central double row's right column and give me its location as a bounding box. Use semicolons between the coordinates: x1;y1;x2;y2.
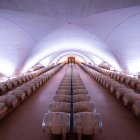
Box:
73;101;96;113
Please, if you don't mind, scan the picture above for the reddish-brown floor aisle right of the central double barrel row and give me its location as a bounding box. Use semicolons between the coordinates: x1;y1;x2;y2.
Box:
77;66;140;140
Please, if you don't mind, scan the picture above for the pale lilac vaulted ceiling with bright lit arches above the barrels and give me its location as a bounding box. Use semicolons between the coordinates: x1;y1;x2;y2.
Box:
0;0;140;74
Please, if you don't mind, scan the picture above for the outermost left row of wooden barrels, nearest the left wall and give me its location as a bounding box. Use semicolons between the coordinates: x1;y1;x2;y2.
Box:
0;64;58;95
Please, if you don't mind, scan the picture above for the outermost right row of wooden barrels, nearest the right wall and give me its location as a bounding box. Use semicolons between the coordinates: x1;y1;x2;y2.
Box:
84;64;140;93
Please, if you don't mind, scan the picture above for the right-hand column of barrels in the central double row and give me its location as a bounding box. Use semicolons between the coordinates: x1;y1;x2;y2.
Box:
72;65;102;140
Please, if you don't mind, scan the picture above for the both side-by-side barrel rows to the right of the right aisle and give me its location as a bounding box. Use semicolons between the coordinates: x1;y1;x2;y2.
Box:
79;64;140;117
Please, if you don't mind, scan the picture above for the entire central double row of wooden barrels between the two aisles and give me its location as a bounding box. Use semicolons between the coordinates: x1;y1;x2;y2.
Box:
42;65;102;140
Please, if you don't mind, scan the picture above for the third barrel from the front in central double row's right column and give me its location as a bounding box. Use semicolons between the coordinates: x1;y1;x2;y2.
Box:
73;94;90;103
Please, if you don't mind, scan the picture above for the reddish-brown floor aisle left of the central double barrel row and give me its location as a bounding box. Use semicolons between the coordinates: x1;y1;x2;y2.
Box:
0;66;67;140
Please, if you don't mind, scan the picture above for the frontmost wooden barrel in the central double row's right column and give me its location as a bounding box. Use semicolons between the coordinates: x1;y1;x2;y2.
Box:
73;112;102;140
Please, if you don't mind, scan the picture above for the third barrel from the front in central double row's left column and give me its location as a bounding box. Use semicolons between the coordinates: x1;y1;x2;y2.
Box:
53;94;71;103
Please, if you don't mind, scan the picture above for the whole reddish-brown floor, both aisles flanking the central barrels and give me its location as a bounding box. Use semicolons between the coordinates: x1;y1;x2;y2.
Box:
0;66;140;140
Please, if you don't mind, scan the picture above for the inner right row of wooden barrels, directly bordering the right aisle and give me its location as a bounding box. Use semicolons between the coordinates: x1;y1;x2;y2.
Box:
79;64;140;117
